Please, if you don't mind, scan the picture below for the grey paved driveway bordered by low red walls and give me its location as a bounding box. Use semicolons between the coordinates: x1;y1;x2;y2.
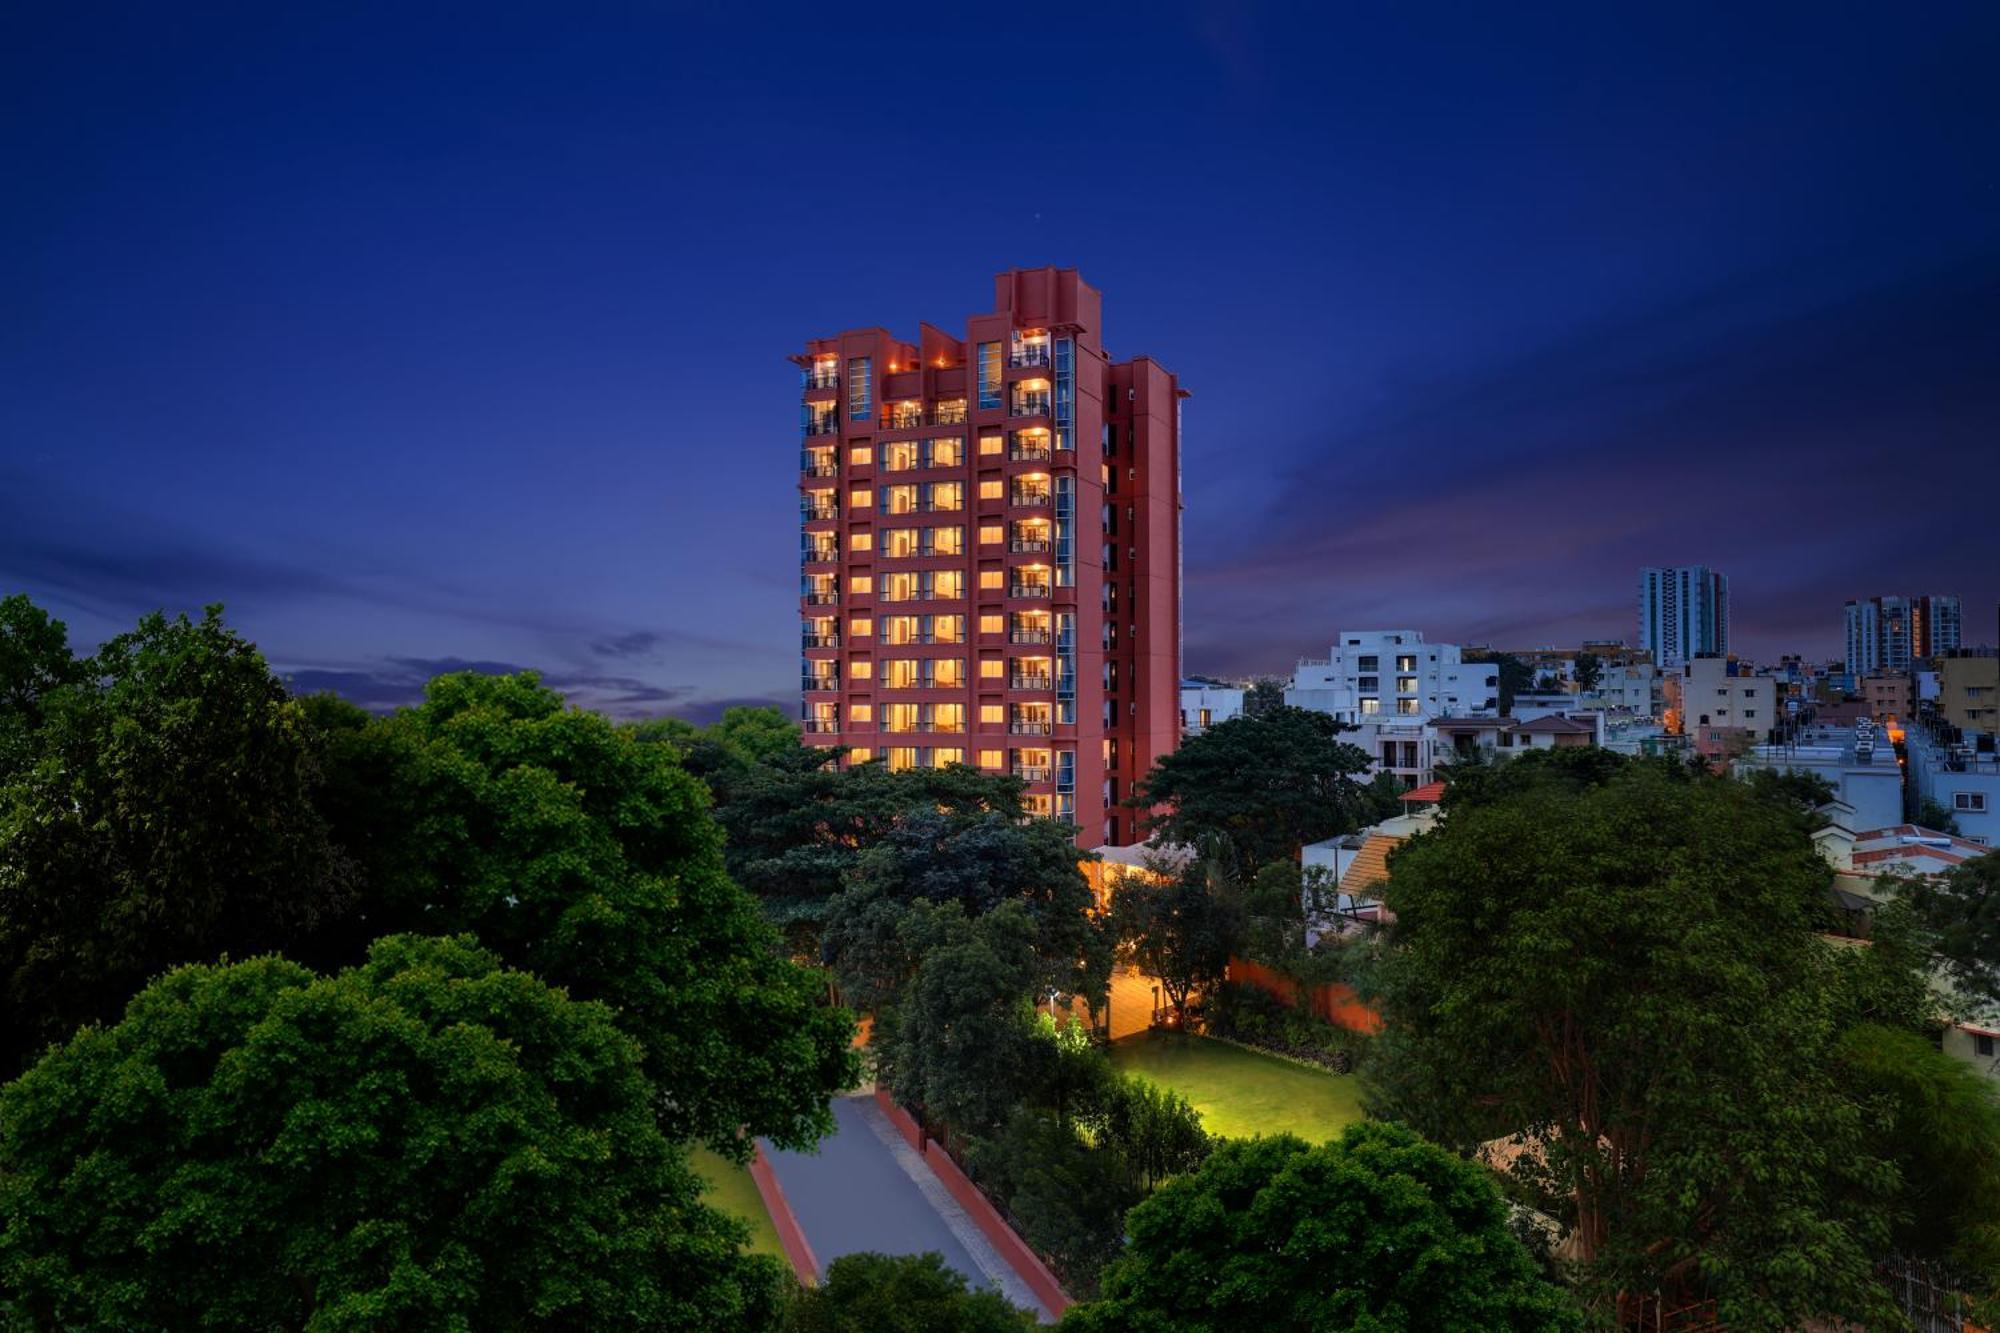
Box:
764;1093;1046;1321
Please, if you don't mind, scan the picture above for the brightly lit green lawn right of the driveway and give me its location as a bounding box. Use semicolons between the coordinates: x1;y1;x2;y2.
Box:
1110;1033;1362;1143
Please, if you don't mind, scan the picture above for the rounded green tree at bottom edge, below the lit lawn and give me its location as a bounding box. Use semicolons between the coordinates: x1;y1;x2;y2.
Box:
1062;1123;1582;1333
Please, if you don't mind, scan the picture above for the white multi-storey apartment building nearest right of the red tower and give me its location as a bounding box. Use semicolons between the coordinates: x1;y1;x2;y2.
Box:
1284;630;1500;723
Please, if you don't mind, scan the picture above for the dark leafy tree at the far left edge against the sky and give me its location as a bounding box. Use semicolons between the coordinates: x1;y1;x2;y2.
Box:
0;602;354;1073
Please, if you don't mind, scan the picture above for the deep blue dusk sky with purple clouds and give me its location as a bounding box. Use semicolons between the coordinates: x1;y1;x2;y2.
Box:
0;2;2000;715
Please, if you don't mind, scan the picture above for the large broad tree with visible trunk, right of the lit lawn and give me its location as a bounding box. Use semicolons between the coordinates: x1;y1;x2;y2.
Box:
1374;761;1910;1327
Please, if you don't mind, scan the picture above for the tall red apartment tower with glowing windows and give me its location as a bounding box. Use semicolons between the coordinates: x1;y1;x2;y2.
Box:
794;268;1186;847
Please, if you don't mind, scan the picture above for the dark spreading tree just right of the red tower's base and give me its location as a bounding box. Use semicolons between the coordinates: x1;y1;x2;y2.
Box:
1132;705;1372;877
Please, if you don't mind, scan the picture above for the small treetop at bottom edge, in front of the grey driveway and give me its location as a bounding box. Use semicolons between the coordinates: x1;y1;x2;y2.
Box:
784;1253;1036;1333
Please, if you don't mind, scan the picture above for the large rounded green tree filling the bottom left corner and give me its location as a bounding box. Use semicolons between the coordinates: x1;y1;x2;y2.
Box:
0;937;780;1331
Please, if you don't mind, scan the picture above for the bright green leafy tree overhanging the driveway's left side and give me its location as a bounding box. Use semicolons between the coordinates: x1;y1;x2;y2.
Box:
308;673;858;1155
